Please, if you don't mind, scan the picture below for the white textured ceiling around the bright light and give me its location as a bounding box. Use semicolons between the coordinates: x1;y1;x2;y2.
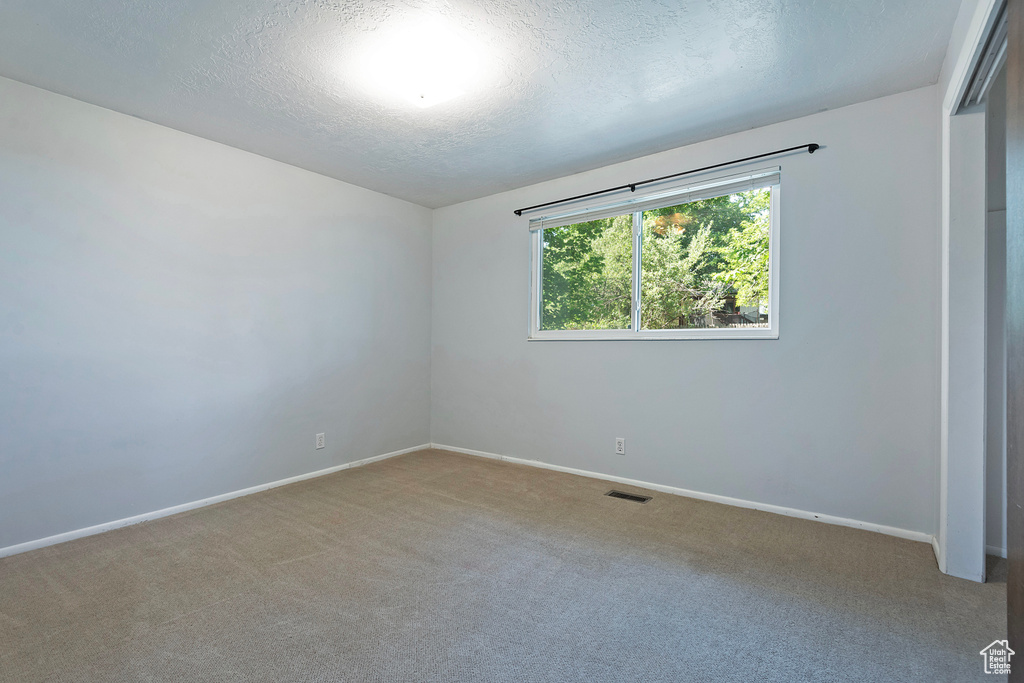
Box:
0;0;959;207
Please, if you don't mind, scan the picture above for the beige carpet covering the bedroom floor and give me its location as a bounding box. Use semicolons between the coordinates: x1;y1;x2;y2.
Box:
0;451;1007;683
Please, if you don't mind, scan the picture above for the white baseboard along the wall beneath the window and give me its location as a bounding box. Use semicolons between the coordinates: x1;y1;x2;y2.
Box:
430;443;935;548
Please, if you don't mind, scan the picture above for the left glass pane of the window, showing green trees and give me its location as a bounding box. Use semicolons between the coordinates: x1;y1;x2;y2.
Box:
541;214;633;330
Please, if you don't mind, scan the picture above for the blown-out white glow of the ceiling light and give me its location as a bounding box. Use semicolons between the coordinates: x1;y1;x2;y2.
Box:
353;17;486;108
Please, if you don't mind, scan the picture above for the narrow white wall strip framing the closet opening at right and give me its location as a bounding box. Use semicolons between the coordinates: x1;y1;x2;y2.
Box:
936;0;996;581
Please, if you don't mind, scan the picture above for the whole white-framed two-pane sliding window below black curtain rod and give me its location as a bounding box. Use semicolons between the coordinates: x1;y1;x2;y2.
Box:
530;168;779;340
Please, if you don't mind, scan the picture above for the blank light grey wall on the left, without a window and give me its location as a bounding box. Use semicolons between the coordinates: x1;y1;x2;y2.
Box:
0;79;431;548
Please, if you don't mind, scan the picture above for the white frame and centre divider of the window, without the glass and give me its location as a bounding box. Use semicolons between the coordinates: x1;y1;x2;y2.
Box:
527;167;781;341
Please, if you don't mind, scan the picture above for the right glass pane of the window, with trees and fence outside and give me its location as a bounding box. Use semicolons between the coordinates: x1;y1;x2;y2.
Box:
640;187;771;330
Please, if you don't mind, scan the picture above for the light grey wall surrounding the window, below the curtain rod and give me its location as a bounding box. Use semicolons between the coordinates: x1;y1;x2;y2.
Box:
431;88;940;533
